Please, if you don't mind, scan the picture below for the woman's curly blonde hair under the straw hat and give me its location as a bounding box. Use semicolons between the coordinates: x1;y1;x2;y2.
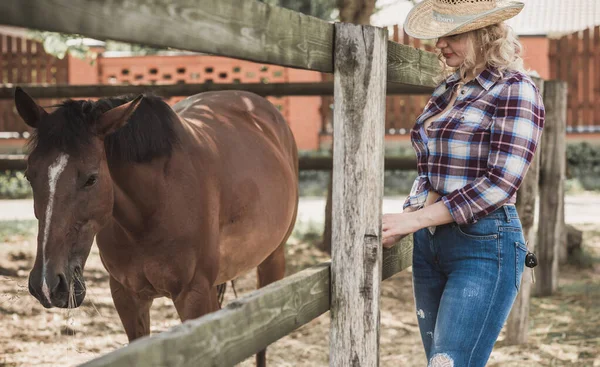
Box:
438;23;527;81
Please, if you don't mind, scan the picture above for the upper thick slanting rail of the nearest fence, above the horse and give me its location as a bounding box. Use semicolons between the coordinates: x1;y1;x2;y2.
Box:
0;0;439;87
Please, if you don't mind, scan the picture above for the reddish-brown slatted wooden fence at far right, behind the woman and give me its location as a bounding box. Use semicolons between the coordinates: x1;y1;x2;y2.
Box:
549;26;600;132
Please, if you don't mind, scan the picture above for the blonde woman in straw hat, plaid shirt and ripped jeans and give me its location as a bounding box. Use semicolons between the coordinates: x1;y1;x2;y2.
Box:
383;0;544;367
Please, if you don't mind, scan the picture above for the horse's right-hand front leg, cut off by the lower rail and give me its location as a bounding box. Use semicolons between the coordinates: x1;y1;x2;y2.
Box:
173;277;219;322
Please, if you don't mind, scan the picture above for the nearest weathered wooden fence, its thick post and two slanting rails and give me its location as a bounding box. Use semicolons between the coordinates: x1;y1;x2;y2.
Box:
0;0;438;366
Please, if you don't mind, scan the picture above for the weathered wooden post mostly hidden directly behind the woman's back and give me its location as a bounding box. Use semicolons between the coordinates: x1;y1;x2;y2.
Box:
504;78;544;345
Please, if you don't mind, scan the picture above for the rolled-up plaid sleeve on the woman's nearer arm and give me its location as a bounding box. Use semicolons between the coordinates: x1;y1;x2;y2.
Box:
442;78;545;225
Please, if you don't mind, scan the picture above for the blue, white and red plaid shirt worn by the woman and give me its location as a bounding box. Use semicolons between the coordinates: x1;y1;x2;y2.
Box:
404;68;545;224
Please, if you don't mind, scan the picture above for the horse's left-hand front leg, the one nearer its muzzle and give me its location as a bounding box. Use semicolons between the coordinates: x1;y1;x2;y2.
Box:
110;276;152;342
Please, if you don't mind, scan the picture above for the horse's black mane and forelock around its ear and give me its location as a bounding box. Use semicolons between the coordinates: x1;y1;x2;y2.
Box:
29;95;178;163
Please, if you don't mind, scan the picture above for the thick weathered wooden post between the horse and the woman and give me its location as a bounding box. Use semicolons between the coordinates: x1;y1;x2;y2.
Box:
330;23;387;367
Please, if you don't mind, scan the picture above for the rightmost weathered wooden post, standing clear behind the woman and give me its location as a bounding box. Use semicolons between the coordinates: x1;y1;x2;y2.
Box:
535;80;567;296
